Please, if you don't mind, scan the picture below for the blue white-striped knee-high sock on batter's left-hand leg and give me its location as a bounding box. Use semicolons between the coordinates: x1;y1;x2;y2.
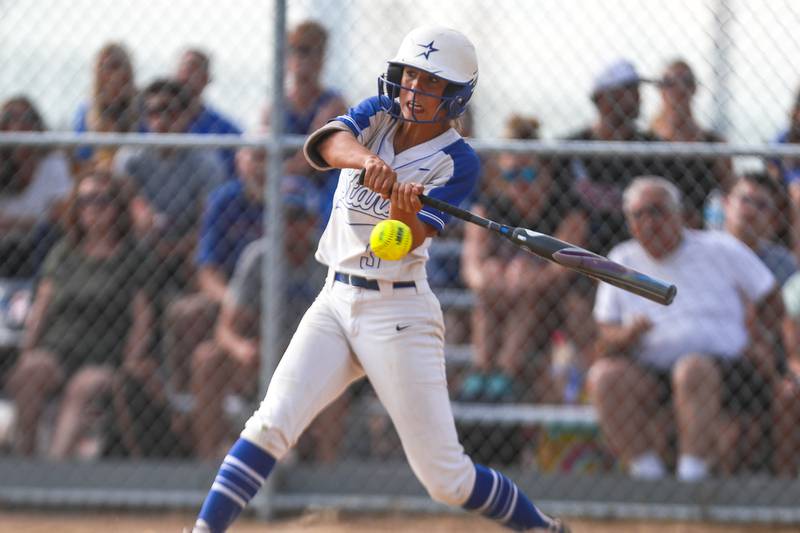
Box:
196;438;275;533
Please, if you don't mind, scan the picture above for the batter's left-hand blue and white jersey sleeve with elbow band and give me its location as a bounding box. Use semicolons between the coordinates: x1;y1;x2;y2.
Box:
303;96;391;171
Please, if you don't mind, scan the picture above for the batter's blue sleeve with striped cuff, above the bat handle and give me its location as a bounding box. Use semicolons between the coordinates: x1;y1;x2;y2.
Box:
417;140;481;231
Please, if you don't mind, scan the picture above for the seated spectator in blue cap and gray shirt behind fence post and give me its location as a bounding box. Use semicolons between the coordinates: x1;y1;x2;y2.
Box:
191;177;326;459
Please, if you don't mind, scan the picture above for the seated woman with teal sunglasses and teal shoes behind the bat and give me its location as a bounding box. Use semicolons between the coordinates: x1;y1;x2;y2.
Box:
459;115;587;401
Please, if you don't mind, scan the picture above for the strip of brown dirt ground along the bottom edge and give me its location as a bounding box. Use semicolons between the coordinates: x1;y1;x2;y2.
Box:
0;511;798;533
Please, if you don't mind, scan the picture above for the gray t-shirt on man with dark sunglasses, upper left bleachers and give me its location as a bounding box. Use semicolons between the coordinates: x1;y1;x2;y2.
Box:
114;148;225;240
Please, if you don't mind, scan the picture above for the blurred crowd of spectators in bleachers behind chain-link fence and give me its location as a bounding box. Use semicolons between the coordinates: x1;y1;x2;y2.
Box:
0;4;800;488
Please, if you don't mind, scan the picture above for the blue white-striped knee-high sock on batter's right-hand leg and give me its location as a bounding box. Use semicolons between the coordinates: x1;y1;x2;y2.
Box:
464;464;553;531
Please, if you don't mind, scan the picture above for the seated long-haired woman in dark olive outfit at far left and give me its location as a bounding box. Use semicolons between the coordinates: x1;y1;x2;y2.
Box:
7;170;153;459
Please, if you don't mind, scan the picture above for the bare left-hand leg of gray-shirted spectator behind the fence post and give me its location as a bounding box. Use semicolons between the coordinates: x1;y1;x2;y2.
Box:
191;341;239;459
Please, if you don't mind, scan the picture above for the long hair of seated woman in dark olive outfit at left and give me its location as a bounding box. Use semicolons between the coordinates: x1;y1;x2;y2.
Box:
63;168;133;246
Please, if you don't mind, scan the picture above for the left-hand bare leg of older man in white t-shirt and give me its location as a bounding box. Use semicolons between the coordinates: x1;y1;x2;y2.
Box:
589;357;666;477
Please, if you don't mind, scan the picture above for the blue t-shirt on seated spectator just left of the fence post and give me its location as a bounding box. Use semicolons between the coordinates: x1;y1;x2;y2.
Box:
195;178;264;277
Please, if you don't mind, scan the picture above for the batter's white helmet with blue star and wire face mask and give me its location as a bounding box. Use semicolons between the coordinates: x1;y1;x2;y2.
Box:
378;27;478;123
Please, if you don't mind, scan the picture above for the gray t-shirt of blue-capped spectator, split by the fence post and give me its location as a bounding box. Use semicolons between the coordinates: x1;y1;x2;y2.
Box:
226;239;326;337
